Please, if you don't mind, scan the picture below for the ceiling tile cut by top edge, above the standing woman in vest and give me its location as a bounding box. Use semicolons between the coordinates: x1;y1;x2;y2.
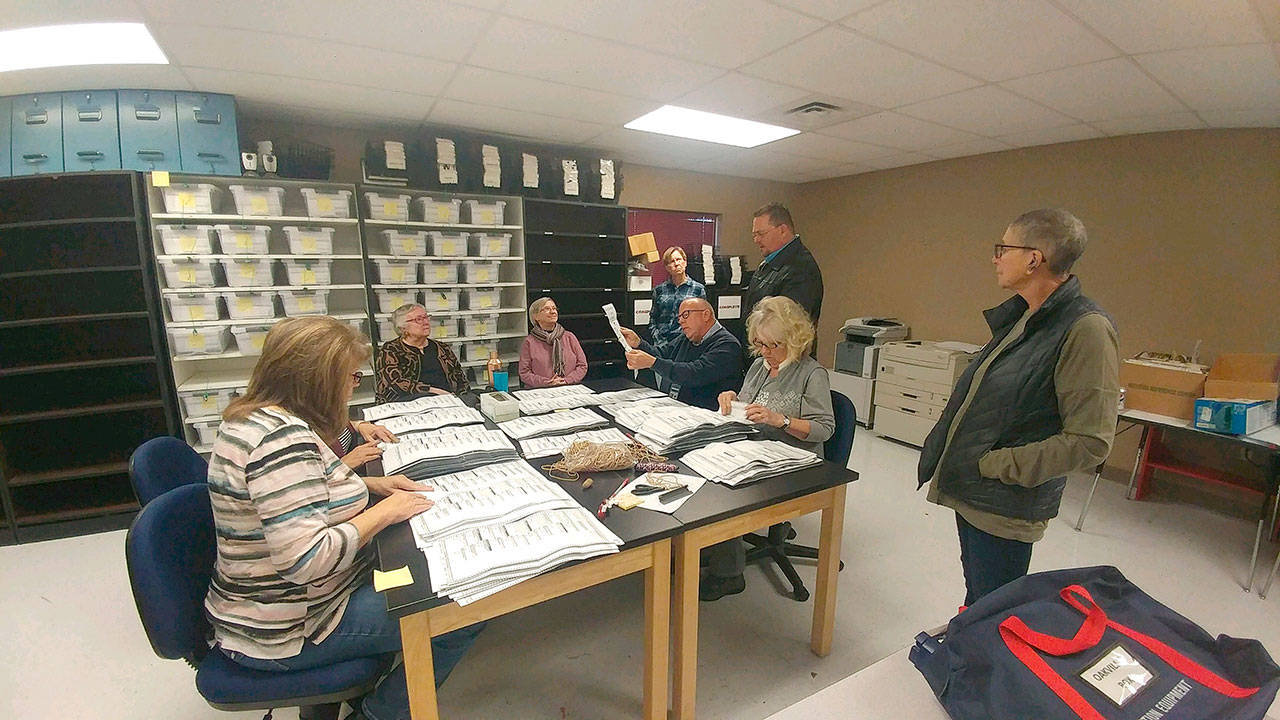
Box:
845;0;1116;81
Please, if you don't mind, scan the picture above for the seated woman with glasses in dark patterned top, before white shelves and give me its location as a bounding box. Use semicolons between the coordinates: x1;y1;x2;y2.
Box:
374;302;470;404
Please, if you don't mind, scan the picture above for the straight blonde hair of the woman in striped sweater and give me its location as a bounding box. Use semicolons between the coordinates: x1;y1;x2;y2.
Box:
223;315;371;438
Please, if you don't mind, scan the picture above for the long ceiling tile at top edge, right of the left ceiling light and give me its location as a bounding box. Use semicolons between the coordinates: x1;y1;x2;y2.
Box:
140;0;493;62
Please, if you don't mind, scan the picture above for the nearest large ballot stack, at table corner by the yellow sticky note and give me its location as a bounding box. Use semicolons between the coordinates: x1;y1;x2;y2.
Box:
410;461;622;605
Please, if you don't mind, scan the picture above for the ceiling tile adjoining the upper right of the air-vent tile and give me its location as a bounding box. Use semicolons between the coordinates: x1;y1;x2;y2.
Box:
742;27;978;108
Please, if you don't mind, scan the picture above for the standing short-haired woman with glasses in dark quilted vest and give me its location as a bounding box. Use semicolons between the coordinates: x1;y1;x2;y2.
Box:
918;210;1120;606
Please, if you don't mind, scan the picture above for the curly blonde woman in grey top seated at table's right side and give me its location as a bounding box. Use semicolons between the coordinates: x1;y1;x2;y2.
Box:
698;296;836;601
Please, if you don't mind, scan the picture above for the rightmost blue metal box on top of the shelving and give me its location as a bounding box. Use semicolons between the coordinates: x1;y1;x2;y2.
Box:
175;92;241;176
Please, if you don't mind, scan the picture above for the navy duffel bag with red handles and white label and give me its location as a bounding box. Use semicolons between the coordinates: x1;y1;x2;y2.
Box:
910;566;1280;720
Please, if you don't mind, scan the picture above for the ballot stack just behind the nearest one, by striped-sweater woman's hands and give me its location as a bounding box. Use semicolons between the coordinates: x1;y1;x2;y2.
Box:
383;425;520;480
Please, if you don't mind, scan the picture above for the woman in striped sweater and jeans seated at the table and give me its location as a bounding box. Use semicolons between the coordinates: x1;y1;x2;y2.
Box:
205;316;480;720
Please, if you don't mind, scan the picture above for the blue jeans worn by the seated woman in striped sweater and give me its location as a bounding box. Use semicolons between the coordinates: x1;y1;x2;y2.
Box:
223;584;485;720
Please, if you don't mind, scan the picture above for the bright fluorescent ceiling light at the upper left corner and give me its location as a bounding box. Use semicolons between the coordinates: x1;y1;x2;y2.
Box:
0;23;169;73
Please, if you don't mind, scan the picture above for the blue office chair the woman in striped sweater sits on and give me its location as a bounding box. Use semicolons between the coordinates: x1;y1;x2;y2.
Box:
124;484;392;720
